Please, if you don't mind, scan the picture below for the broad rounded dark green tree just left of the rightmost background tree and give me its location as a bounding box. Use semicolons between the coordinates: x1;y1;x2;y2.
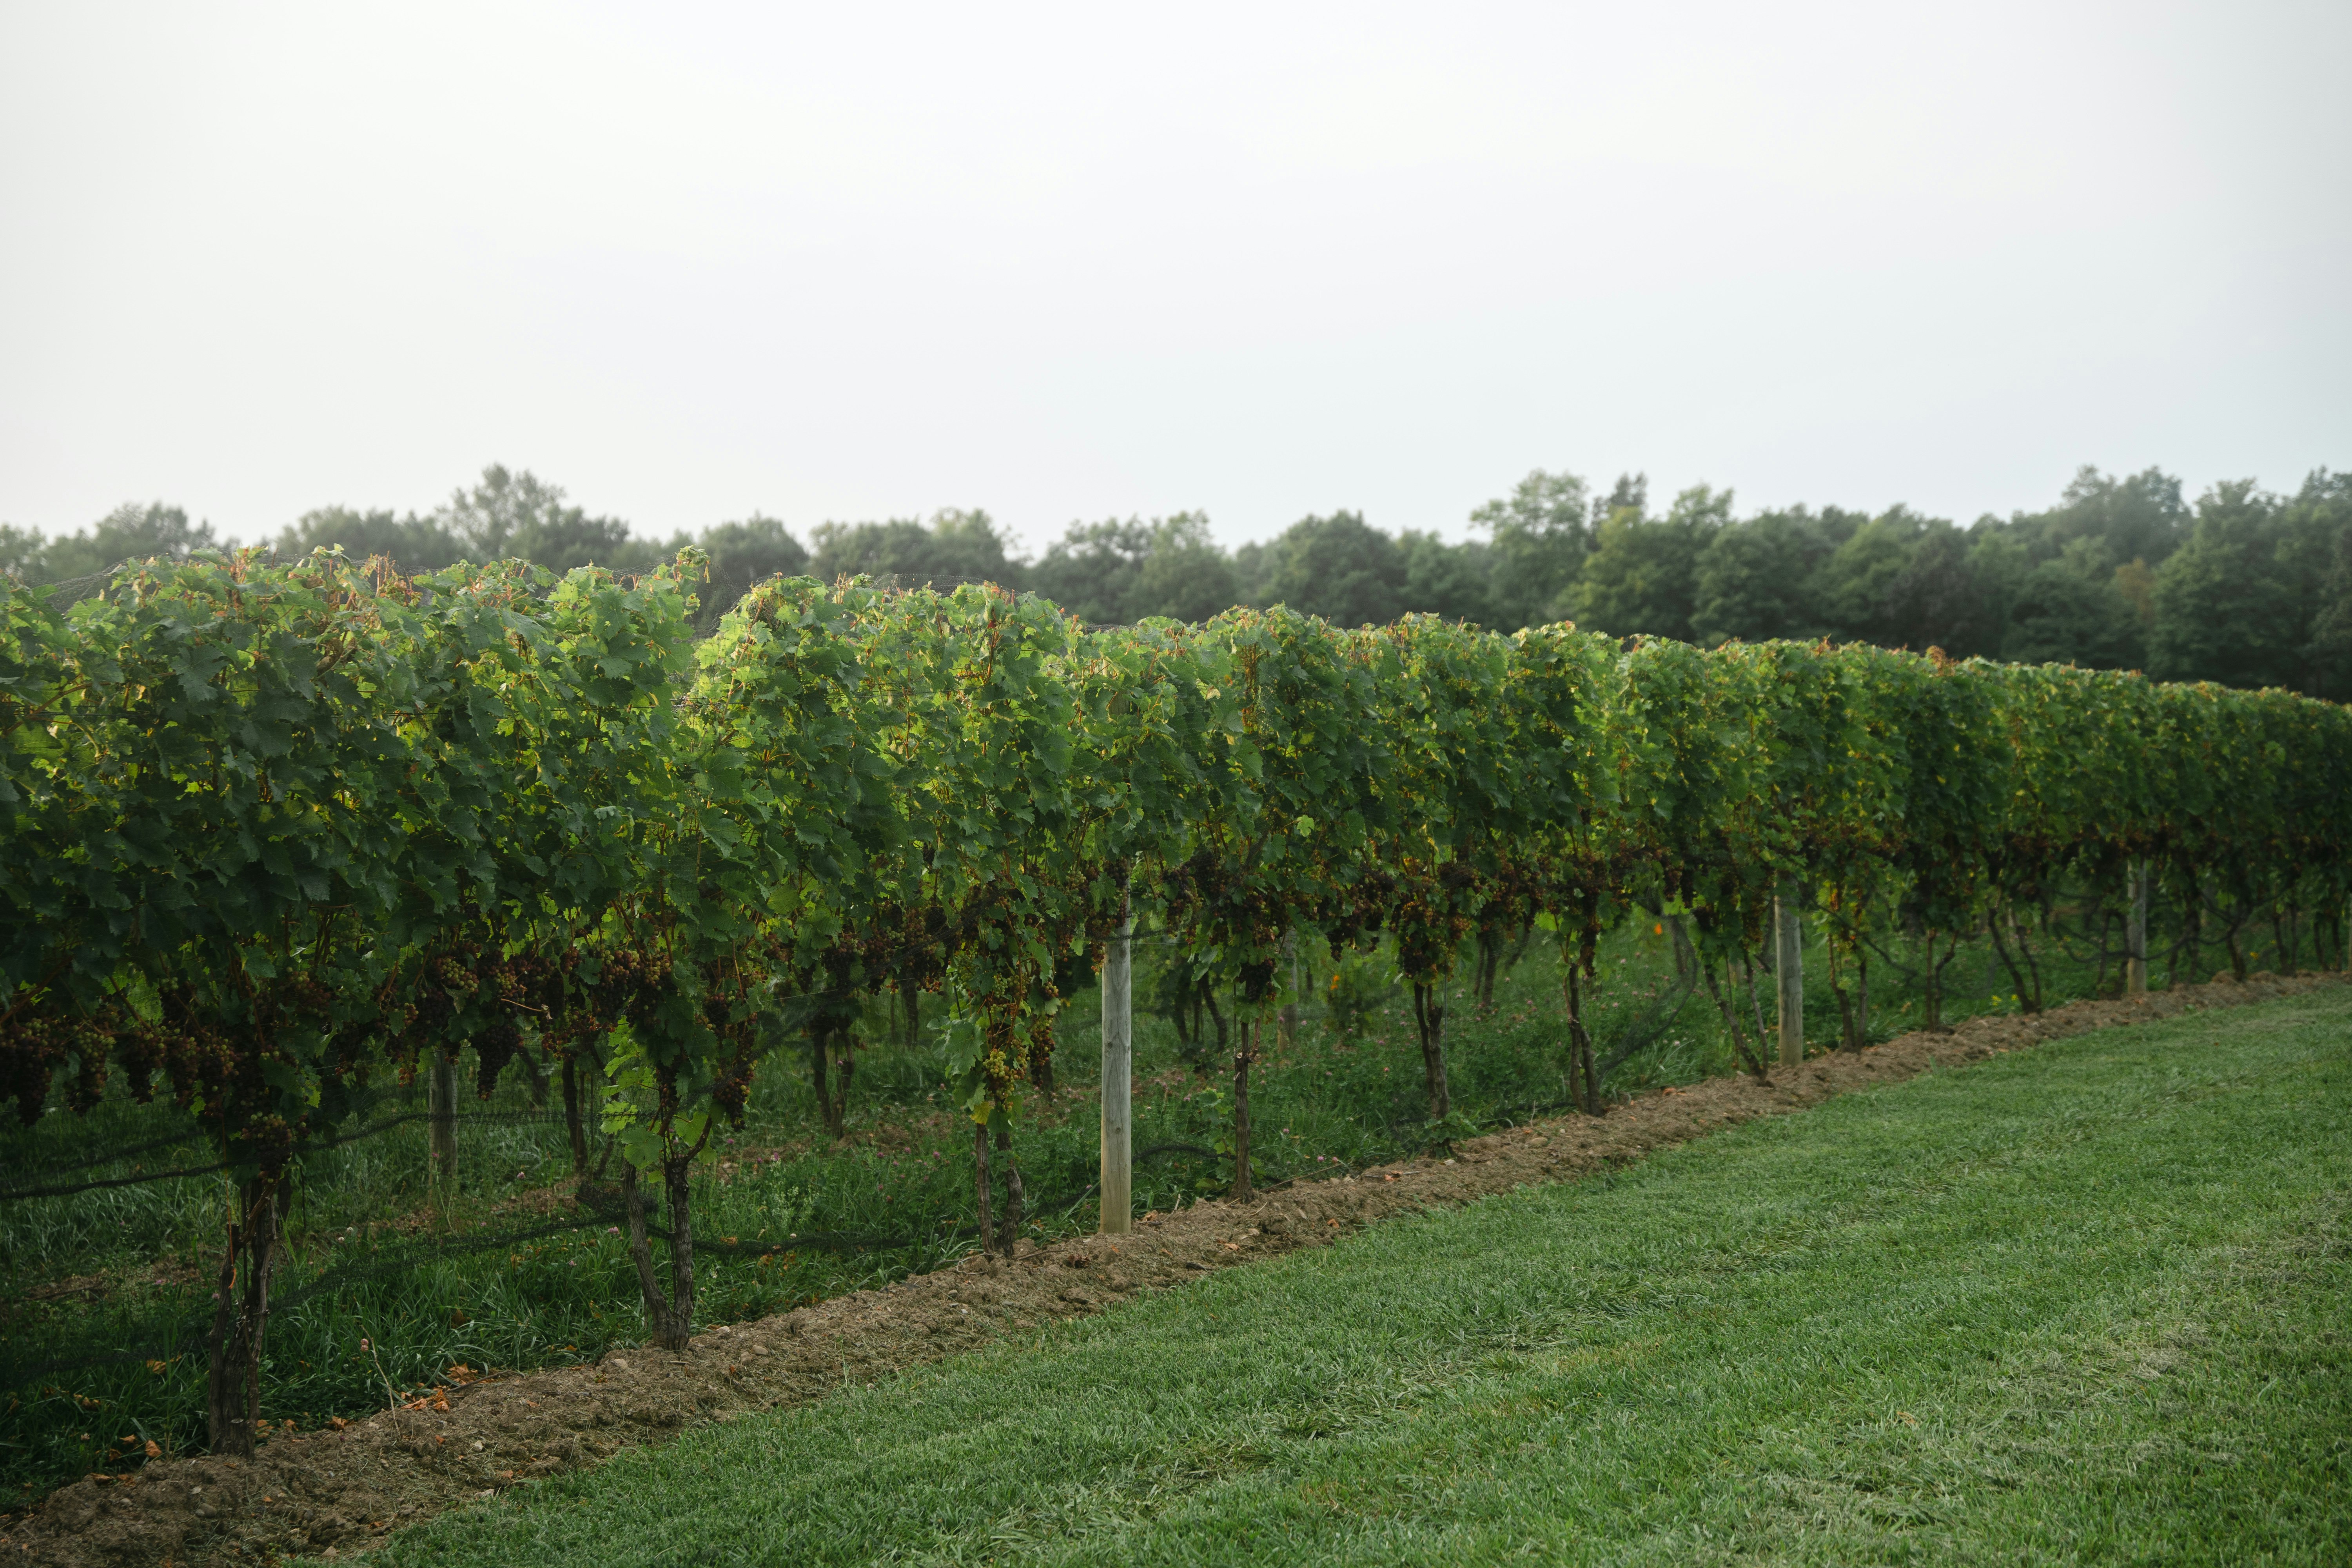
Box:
2147;479;2305;686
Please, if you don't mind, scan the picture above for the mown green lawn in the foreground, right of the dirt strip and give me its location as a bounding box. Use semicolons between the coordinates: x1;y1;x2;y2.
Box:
381;987;2352;1568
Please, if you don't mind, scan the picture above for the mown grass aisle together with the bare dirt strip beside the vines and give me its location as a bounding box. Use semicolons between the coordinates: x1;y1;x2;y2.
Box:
23;980;2352;1563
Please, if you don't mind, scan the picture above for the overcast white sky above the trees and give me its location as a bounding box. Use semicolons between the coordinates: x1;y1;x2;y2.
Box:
0;0;2352;548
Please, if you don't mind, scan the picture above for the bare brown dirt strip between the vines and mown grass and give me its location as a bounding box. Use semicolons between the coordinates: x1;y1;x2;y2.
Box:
0;976;2340;1568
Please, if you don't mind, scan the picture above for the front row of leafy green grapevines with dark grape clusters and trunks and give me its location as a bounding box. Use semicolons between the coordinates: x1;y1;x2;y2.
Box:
0;552;2352;1453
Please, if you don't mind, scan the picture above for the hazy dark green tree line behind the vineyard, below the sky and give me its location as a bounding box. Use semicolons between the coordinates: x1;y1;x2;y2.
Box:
0;465;2352;701
